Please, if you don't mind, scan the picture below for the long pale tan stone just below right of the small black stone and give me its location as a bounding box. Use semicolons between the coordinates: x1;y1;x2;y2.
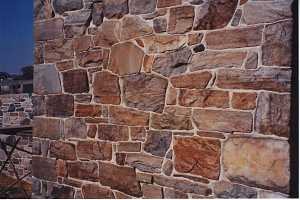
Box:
189;51;247;71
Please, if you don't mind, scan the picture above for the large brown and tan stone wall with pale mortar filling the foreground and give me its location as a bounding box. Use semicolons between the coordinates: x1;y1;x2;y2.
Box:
33;0;292;198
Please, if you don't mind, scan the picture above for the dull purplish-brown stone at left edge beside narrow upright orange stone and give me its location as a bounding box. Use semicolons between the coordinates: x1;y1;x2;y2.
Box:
32;156;57;181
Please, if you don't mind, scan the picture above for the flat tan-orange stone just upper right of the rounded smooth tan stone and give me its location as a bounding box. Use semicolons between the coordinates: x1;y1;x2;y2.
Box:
142;35;187;54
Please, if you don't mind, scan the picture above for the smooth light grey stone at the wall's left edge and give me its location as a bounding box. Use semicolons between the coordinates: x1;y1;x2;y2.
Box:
33;64;62;94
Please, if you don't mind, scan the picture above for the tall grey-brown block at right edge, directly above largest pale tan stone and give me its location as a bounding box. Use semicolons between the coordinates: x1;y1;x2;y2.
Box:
255;92;291;137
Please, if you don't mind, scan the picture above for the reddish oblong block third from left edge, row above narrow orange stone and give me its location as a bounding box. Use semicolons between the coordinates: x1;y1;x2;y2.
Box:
77;141;112;160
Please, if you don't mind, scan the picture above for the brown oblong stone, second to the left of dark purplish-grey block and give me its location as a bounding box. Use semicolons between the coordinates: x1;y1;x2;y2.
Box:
98;124;129;142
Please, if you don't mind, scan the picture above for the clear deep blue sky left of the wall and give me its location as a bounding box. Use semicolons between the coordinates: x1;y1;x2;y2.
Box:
0;0;34;73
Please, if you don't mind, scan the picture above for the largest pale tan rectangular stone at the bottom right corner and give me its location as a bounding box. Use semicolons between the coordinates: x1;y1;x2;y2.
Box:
223;137;290;193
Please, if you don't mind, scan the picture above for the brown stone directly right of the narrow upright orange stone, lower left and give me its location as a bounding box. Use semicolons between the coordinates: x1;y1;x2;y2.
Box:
67;161;99;181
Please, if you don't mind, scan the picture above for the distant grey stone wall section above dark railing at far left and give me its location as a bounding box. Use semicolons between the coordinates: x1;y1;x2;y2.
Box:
0;94;33;128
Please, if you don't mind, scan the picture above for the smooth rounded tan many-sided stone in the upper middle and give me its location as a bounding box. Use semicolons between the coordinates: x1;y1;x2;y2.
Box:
108;42;144;75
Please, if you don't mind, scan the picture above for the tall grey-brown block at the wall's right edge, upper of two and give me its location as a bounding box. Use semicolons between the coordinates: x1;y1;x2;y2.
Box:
262;20;293;67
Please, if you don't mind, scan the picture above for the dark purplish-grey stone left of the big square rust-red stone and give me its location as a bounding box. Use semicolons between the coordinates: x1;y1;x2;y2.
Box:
144;131;172;157
